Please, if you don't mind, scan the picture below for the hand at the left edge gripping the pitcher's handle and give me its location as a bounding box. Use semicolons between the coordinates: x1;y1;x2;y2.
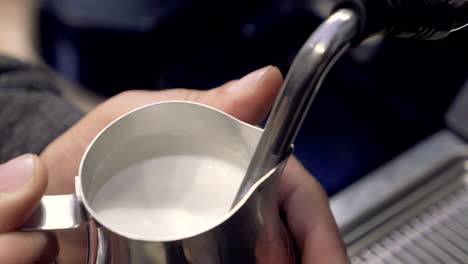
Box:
0;154;58;264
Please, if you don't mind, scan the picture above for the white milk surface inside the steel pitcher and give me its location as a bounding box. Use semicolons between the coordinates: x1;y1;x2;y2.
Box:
92;151;245;239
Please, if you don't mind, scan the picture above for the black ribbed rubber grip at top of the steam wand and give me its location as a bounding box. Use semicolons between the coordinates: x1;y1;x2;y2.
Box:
333;0;468;44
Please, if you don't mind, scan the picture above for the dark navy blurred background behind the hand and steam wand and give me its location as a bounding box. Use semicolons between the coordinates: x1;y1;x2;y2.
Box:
30;0;468;195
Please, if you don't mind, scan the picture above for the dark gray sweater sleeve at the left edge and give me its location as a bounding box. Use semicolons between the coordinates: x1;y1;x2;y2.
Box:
0;56;83;163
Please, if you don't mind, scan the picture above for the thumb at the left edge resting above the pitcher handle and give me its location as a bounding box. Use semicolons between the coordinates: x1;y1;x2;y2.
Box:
0;154;47;234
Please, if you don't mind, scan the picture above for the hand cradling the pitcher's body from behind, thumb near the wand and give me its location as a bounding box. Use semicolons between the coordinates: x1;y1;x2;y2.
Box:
41;67;346;263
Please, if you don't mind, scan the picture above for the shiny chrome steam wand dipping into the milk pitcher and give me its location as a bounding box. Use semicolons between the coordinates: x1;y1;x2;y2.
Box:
233;9;358;205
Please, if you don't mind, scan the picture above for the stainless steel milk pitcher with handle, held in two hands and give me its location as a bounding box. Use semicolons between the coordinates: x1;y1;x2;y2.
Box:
24;101;294;264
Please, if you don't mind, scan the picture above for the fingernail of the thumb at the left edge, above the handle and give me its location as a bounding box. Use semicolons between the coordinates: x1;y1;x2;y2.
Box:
0;154;34;193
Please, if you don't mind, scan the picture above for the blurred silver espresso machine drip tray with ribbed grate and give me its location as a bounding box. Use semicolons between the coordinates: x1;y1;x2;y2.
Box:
331;82;468;263
